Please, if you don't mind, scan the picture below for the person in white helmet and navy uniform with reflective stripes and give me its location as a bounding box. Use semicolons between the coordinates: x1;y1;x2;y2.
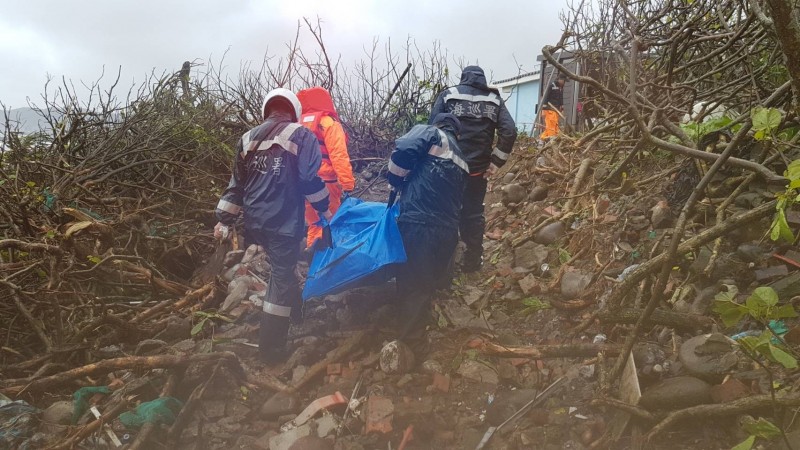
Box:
214;89;331;362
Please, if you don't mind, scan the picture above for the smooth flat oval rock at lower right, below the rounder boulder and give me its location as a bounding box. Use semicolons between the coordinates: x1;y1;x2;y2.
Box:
639;377;711;409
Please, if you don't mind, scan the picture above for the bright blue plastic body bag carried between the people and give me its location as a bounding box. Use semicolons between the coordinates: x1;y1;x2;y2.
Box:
303;197;406;300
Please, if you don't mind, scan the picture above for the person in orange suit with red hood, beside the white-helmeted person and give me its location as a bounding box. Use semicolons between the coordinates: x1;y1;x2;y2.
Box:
297;87;356;248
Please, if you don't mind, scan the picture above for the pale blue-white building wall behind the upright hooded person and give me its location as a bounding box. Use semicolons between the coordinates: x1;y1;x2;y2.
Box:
492;70;540;135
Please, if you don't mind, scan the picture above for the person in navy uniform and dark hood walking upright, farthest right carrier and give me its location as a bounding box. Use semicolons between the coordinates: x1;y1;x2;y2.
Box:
431;66;517;272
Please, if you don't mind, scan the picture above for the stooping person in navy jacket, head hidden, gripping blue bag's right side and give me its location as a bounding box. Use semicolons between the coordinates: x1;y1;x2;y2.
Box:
388;114;469;339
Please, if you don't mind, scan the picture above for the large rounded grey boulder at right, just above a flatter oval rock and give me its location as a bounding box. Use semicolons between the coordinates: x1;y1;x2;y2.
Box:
678;333;739;382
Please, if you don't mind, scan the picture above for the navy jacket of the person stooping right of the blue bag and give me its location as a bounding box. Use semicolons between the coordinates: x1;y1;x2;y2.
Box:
387;125;469;228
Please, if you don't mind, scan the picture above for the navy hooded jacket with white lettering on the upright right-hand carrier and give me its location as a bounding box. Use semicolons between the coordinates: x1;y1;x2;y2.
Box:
430;66;517;174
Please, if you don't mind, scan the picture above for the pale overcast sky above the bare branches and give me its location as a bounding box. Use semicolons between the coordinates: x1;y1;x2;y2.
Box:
0;0;566;108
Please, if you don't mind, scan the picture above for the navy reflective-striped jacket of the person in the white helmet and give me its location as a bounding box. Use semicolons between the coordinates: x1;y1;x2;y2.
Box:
215;112;328;237
